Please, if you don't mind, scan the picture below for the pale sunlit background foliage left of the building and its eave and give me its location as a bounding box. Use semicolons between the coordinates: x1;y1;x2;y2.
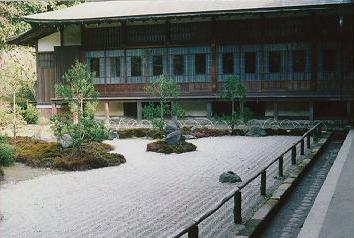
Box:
0;0;78;126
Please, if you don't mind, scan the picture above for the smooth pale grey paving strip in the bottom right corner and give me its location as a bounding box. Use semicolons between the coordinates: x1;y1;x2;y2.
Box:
298;130;354;238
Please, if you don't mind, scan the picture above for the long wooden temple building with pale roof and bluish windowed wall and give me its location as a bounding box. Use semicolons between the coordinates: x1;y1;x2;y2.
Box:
9;0;354;120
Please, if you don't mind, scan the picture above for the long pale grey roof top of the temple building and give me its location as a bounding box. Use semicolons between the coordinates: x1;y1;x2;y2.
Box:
24;0;353;23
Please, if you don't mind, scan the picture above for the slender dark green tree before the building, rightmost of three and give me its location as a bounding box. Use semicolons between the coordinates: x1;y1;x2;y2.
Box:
220;75;250;134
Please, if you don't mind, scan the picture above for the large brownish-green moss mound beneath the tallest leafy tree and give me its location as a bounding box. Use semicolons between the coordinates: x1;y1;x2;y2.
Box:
12;137;125;171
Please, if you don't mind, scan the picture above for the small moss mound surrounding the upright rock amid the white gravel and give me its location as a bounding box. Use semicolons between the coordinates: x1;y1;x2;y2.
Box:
146;140;197;154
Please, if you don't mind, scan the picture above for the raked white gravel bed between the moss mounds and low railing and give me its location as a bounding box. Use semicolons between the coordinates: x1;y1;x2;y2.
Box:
0;136;298;238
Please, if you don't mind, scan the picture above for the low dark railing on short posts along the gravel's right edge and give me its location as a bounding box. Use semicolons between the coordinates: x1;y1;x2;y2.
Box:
172;122;322;238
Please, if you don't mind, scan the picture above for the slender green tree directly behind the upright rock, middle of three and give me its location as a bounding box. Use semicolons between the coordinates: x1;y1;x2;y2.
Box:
143;75;184;130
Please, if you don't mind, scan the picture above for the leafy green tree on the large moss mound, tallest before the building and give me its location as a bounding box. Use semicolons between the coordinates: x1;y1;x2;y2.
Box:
52;61;109;148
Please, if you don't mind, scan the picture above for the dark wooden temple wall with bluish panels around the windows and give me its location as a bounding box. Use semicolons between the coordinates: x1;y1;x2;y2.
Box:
37;15;354;102
